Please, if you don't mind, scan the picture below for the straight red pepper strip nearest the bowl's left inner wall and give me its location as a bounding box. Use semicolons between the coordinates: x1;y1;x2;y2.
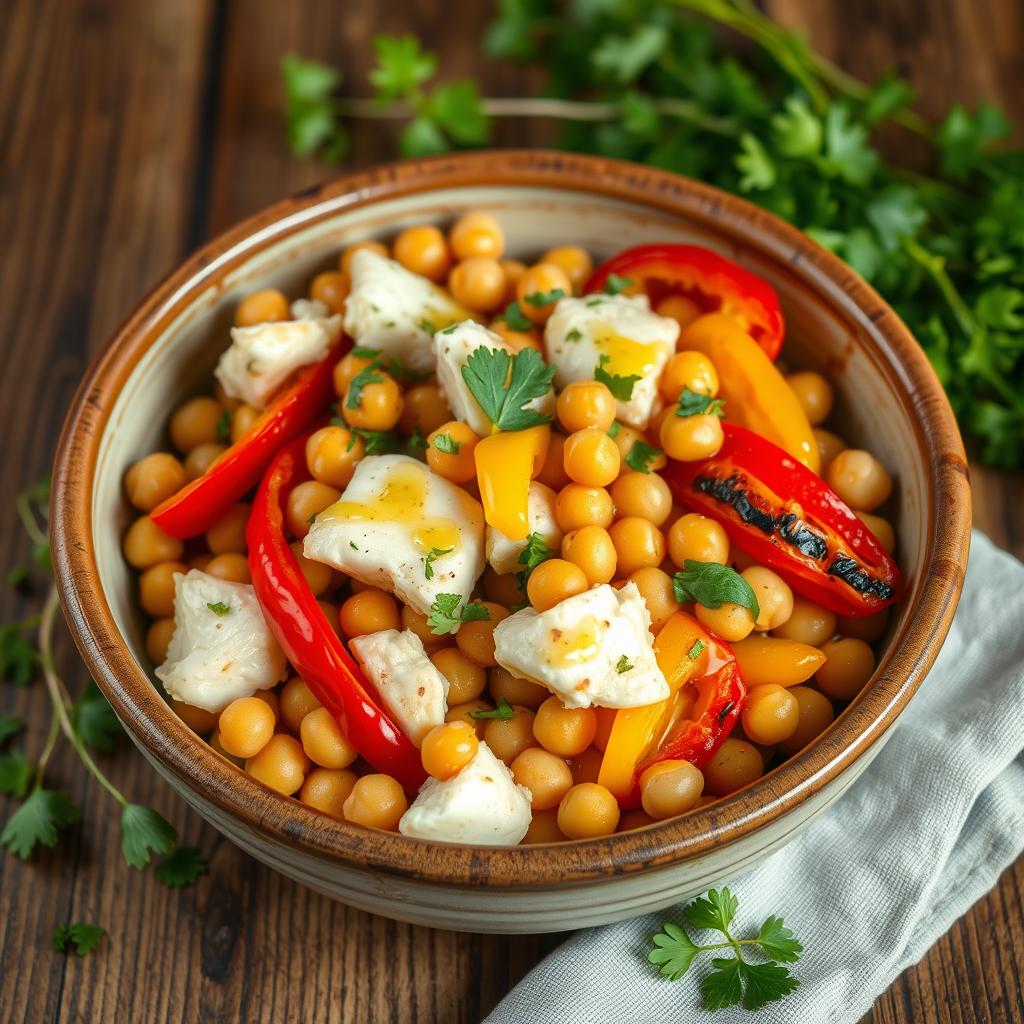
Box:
150;337;351;540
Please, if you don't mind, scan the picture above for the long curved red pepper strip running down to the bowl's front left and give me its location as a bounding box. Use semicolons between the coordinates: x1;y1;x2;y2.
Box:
246;436;426;793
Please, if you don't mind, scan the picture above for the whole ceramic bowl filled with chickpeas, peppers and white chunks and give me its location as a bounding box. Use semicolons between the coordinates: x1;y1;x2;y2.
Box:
51;152;970;932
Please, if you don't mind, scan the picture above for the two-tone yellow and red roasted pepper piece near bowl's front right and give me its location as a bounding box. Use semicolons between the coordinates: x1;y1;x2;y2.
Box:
598;611;745;807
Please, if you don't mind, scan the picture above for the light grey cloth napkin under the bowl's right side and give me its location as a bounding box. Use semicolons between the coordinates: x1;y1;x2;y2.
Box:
487;532;1024;1024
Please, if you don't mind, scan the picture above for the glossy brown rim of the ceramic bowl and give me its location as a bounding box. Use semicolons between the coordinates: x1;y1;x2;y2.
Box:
51;151;970;889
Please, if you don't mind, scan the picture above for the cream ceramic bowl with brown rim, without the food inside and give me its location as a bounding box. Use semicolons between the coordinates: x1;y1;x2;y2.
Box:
51;152;970;932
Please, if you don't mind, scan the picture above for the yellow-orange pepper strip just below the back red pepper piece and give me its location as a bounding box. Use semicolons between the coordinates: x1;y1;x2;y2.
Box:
676;313;821;473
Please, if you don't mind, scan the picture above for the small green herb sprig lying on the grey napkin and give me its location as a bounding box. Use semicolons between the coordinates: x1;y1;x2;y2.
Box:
647;889;804;1011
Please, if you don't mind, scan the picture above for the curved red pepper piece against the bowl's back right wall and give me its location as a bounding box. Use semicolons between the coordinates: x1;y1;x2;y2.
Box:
584;243;785;359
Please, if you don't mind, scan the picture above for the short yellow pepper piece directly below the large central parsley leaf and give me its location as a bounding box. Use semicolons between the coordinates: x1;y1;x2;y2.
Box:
473;424;551;541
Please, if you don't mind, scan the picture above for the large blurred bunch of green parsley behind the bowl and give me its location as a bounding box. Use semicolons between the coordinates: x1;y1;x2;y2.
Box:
283;0;1024;468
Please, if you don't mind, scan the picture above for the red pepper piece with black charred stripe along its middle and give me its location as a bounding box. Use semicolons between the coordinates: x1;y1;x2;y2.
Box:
662;423;901;615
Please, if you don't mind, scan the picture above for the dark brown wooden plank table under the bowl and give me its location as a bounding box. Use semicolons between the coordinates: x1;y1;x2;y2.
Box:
0;0;1024;1024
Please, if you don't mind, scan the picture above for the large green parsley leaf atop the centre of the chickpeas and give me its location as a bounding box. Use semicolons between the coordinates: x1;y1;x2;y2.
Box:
462;348;555;430
